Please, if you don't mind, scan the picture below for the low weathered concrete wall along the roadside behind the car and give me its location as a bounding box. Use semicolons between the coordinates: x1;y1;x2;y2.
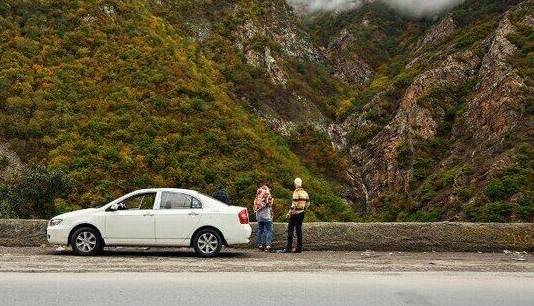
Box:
0;220;534;251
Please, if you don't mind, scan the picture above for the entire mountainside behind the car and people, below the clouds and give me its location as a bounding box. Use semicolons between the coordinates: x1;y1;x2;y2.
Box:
0;0;534;222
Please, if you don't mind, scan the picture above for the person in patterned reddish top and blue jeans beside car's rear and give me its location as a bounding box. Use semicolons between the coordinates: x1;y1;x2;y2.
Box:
254;184;273;252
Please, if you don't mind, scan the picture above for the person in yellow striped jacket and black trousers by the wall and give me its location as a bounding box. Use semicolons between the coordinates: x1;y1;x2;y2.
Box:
283;178;310;253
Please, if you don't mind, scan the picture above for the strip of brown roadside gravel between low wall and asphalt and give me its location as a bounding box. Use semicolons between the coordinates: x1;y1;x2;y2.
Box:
0;247;534;272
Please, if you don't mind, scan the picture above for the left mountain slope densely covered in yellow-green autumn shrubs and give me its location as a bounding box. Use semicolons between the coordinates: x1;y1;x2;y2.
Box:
0;1;360;220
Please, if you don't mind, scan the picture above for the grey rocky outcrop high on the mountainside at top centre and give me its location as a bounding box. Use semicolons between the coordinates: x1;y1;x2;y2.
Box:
231;1;326;136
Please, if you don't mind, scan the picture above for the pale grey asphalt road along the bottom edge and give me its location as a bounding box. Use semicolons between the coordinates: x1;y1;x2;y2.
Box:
0;272;534;306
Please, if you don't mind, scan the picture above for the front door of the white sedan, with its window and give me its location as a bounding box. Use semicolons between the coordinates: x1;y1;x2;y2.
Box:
105;192;157;245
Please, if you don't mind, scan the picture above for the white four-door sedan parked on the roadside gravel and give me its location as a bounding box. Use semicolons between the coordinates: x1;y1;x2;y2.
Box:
47;189;252;257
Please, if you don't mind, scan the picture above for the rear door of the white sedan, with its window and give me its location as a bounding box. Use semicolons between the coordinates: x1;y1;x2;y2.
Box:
154;191;202;246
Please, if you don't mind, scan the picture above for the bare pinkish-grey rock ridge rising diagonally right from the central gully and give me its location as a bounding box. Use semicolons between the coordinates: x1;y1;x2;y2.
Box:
351;51;480;208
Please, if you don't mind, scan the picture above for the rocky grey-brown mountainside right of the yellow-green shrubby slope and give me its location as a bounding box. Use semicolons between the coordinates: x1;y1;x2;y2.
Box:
199;1;532;220
